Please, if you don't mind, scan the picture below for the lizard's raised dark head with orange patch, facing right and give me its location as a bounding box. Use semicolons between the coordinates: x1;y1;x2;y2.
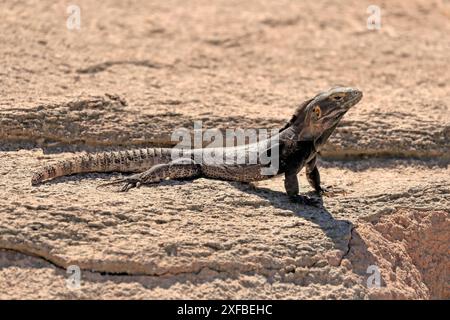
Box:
293;87;362;145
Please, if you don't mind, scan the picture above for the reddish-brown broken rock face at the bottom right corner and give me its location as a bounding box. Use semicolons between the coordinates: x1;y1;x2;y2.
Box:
342;208;450;299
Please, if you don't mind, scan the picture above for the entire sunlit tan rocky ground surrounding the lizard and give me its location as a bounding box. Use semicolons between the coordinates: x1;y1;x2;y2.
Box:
0;0;450;299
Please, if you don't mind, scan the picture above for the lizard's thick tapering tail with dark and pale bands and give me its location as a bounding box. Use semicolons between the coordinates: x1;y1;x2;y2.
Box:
31;148;171;185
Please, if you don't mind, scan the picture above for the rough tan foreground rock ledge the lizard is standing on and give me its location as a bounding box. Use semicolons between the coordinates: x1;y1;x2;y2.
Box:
0;150;450;298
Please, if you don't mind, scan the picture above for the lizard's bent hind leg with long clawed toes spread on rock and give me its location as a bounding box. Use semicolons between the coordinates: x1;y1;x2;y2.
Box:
100;158;201;192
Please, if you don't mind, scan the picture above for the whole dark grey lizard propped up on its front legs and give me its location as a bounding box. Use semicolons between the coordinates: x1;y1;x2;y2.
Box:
31;86;363;204
